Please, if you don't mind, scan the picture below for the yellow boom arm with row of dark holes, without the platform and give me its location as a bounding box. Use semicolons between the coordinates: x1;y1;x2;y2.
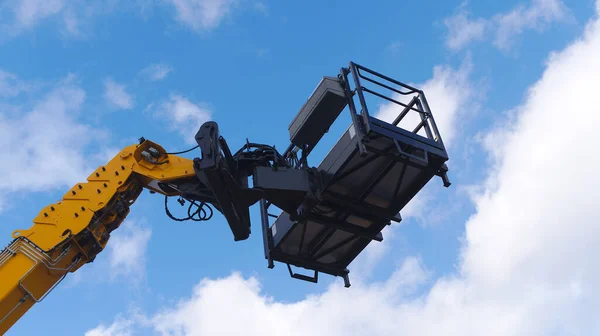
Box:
0;140;196;334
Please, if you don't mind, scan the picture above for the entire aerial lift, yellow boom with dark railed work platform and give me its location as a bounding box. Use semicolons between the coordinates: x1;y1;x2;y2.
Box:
0;62;450;334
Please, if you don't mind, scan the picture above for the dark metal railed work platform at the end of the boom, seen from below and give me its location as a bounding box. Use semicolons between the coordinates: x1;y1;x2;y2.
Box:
261;63;450;286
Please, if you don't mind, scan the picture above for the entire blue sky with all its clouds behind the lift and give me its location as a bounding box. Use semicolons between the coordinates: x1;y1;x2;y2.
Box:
0;0;600;336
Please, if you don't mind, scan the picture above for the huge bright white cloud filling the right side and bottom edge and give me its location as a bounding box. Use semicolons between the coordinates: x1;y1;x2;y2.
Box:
89;2;600;336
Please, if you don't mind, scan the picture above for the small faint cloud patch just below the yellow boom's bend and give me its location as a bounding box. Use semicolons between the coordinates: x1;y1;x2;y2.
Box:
108;220;152;282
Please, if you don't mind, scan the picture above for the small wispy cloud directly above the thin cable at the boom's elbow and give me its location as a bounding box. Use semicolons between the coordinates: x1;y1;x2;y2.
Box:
146;94;212;144
